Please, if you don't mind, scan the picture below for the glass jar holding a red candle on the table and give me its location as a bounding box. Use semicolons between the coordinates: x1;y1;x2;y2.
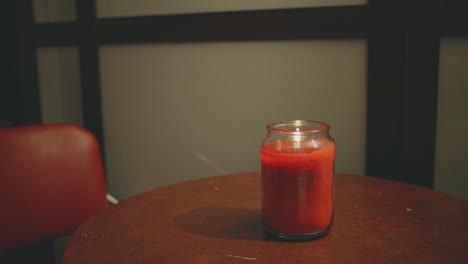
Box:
260;120;336;241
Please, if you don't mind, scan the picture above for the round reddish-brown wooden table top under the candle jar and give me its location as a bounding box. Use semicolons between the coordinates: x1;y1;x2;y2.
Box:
63;173;468;264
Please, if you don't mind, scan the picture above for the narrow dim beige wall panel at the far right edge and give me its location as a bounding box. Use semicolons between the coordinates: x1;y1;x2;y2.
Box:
435;38;468;201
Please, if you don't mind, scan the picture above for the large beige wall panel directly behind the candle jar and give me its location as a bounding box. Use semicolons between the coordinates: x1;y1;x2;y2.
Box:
100;40;367;198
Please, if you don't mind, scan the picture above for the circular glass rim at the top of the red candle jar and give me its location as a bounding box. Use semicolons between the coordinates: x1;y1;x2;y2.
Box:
267;119;330;133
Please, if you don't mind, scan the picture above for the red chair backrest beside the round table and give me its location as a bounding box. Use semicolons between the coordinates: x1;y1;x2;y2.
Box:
0;124;108;253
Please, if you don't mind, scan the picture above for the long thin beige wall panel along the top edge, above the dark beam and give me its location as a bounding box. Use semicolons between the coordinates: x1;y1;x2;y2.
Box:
96;0;367;17
